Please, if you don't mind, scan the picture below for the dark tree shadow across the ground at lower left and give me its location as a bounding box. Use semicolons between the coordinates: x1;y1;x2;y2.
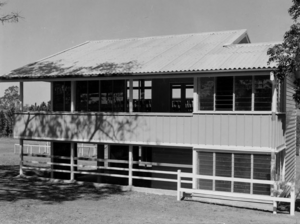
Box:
0;166;124;204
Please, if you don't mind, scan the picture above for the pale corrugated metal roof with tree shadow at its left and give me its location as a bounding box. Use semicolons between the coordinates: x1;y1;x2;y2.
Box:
0;30;276;79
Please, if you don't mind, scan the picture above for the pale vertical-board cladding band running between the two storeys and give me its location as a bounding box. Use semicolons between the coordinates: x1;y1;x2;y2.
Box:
14;112;283;149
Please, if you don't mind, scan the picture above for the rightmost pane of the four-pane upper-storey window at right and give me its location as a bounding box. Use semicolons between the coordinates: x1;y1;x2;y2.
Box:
254;75;272;111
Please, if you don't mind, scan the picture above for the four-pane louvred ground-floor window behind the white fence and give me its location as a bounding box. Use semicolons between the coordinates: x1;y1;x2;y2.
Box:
198;151;271;195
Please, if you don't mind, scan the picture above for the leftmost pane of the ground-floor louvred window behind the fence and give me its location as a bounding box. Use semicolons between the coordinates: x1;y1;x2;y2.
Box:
198;152;213;190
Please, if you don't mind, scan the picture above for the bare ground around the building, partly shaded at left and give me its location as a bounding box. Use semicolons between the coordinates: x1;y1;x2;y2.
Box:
0;138;300;224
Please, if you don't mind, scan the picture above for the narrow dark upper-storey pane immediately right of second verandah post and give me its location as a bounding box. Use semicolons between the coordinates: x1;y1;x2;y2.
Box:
76;81;88;111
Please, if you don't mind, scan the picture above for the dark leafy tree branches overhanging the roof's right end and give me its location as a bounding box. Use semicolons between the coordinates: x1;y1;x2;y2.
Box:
268;0;300;103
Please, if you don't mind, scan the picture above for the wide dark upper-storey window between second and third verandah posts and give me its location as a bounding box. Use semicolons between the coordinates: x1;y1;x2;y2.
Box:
76;80;126;112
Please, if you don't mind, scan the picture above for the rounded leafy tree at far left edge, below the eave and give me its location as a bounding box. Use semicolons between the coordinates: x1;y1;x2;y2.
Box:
0;86;20;110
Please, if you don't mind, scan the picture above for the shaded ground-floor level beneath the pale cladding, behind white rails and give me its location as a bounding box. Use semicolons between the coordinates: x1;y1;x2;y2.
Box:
17;141;278;195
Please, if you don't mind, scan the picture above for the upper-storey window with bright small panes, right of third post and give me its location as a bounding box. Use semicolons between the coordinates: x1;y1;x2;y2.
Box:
127;80;152;112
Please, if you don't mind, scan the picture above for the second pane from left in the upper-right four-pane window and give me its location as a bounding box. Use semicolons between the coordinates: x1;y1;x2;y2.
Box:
216;77;233;111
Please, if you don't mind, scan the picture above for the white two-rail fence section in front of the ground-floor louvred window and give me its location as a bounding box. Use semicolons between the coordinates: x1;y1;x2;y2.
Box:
177;170;296;215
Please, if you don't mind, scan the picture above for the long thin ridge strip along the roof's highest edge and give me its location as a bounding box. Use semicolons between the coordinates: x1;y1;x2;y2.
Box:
90;29;247;42
